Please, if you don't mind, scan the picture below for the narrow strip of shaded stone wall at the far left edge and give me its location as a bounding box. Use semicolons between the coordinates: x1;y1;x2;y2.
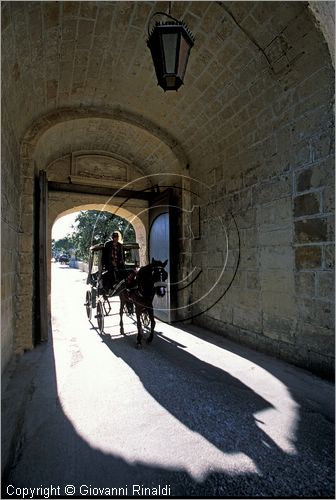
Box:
1;110;20;371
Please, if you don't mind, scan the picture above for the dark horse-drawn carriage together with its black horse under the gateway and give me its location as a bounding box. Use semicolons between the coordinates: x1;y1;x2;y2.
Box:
84;243;168;345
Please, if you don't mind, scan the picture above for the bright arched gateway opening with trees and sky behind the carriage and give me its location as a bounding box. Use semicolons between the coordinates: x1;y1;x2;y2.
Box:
43;203;148;342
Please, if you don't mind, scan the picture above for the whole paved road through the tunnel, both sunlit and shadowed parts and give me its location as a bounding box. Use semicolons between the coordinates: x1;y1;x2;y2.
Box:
3;264;334;498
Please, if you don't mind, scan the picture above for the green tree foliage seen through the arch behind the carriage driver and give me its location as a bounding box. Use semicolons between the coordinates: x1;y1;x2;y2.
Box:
70;210;136;261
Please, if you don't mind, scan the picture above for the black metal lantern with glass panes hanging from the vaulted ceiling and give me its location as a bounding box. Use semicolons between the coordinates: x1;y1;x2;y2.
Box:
147;12;194;91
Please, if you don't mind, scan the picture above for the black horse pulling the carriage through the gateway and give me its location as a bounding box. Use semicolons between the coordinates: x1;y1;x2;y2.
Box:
118;259;168;347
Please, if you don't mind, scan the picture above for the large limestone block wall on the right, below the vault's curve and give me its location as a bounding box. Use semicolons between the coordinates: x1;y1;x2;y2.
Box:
193;149;334;374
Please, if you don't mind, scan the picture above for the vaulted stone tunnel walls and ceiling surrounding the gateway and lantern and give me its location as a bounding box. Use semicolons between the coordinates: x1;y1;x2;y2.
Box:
2;2;334;376
